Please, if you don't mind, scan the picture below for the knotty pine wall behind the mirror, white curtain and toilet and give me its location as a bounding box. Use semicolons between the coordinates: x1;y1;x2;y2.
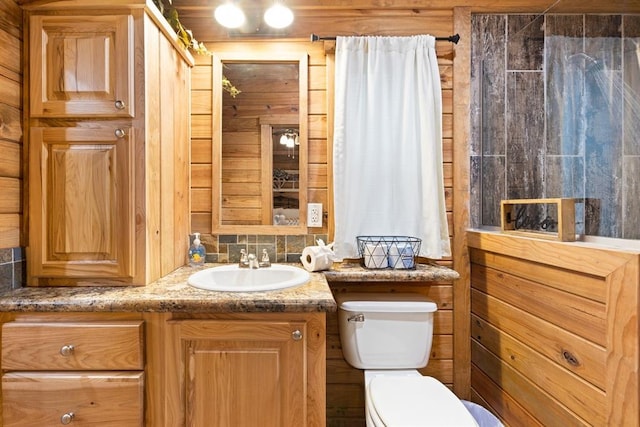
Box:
191;10;470;427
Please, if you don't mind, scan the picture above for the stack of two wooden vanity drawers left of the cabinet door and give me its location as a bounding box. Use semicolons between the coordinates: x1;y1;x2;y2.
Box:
2;316;145;427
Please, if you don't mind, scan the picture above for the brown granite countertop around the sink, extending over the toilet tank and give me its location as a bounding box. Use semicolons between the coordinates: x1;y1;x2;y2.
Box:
0;262;459;313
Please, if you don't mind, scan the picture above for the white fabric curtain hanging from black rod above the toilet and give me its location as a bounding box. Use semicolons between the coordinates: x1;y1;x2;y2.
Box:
333;35;451;259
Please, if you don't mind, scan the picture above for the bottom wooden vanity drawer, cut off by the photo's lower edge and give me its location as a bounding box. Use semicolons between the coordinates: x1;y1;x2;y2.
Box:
2;371;144;427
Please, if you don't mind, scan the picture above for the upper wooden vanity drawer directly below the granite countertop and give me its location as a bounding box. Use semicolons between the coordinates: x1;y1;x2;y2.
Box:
2;320;144;371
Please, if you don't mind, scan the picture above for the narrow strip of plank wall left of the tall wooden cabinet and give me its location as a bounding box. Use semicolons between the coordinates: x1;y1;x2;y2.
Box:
0;0;23;248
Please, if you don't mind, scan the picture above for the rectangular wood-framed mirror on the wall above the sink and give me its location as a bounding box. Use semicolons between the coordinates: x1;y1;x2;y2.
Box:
212;52;308;234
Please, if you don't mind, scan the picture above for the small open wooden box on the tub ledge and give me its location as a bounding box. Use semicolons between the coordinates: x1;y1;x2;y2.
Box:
500;198;576;242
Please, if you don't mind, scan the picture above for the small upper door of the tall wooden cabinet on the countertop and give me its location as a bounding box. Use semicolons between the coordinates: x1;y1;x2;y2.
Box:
29;15;134;117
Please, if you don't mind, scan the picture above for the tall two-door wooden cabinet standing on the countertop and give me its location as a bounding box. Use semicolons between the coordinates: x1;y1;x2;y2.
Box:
24;0;193;286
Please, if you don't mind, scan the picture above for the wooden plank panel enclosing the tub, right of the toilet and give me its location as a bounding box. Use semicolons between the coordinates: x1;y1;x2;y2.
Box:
469;232;640;426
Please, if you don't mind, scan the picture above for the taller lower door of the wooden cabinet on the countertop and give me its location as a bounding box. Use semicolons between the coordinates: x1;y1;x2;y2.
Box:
29;125;135;278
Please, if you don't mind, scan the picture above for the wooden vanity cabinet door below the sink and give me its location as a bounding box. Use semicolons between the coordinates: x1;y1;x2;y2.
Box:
169;320;306;427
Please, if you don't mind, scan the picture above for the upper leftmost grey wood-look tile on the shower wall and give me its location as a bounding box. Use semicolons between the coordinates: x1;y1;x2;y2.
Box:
470;15;506;155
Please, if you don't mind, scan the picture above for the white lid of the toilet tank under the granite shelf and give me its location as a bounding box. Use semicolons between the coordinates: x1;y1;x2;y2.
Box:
336;292;438;313
